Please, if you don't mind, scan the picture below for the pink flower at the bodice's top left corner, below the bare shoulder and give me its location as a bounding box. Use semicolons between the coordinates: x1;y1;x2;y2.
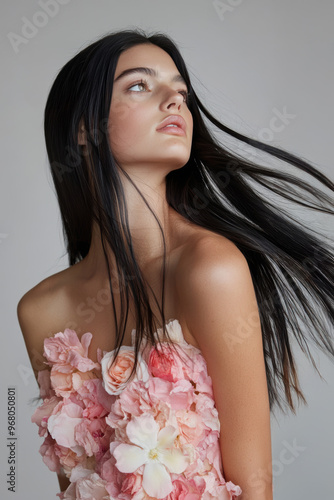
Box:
44;328;100;373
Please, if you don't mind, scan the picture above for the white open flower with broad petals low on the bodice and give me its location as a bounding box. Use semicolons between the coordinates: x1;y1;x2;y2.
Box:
114;415;188;498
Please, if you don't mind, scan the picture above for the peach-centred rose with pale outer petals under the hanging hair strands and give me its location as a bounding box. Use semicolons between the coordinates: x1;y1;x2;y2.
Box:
101;346;149;395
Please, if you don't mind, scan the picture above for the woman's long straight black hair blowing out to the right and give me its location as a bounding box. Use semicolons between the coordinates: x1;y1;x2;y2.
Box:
44;29;334;413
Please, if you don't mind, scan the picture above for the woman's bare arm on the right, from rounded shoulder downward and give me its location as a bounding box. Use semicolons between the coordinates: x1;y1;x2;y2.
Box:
179;240;273;500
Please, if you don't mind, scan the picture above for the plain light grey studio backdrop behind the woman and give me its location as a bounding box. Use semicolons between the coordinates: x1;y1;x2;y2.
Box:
0;0;334;500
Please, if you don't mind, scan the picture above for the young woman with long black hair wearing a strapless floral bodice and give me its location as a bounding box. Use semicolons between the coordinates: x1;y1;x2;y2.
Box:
18;30;334;500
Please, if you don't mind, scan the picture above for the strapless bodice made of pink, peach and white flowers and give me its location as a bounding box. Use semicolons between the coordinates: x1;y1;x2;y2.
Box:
31;319;242;500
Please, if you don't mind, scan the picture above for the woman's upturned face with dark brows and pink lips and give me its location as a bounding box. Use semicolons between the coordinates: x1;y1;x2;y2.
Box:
109;44;193;175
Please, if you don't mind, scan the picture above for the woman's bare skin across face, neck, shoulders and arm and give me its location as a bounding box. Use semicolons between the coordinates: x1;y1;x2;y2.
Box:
17;44;273;500
